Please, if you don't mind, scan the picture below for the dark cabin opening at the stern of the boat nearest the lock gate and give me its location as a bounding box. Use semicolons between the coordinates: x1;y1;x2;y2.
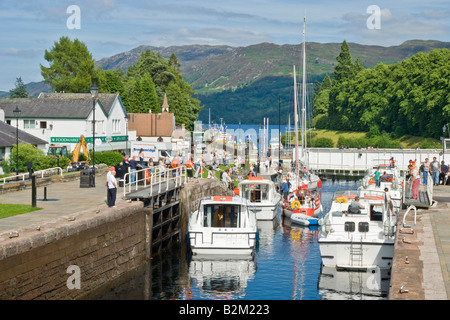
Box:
203;204;241;228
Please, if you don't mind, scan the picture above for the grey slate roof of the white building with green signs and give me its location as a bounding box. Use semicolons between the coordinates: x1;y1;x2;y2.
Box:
0;93;120;119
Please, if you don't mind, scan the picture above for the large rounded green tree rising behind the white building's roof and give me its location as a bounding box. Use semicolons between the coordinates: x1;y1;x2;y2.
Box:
41;36;100;92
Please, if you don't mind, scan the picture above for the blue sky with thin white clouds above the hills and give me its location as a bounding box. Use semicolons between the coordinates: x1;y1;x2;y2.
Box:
0;0;450;91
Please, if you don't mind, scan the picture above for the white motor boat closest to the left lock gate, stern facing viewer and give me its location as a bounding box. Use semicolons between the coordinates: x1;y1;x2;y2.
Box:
188;196;257;255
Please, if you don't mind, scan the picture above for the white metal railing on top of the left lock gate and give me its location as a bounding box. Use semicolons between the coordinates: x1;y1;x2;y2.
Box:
123;166;187;197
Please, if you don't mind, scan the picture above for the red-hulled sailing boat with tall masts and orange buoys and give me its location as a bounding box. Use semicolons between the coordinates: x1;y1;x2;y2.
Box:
283;19;322;225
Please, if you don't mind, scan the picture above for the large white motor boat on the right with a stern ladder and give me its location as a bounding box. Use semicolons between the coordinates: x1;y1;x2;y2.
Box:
319;190;396;270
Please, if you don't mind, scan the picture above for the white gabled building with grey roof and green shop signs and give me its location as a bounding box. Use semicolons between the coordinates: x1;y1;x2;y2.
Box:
0;93;135;152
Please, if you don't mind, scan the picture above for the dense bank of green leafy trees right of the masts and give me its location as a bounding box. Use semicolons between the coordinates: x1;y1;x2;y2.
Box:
314;42;450;138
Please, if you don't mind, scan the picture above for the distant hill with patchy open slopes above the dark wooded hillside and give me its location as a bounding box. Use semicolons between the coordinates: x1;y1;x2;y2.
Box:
96;40;450;94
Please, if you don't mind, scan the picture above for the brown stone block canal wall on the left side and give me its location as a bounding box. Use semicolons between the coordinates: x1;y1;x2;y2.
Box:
0;202;151;300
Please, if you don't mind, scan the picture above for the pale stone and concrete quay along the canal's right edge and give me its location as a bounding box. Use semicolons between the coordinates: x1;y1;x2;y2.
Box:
389;185;450;300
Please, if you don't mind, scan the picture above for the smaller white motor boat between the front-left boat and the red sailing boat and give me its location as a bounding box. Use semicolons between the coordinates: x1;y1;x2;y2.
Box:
238;177;281;220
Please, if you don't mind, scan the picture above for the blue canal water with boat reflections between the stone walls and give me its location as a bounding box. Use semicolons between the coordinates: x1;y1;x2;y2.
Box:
93;180;389;300
